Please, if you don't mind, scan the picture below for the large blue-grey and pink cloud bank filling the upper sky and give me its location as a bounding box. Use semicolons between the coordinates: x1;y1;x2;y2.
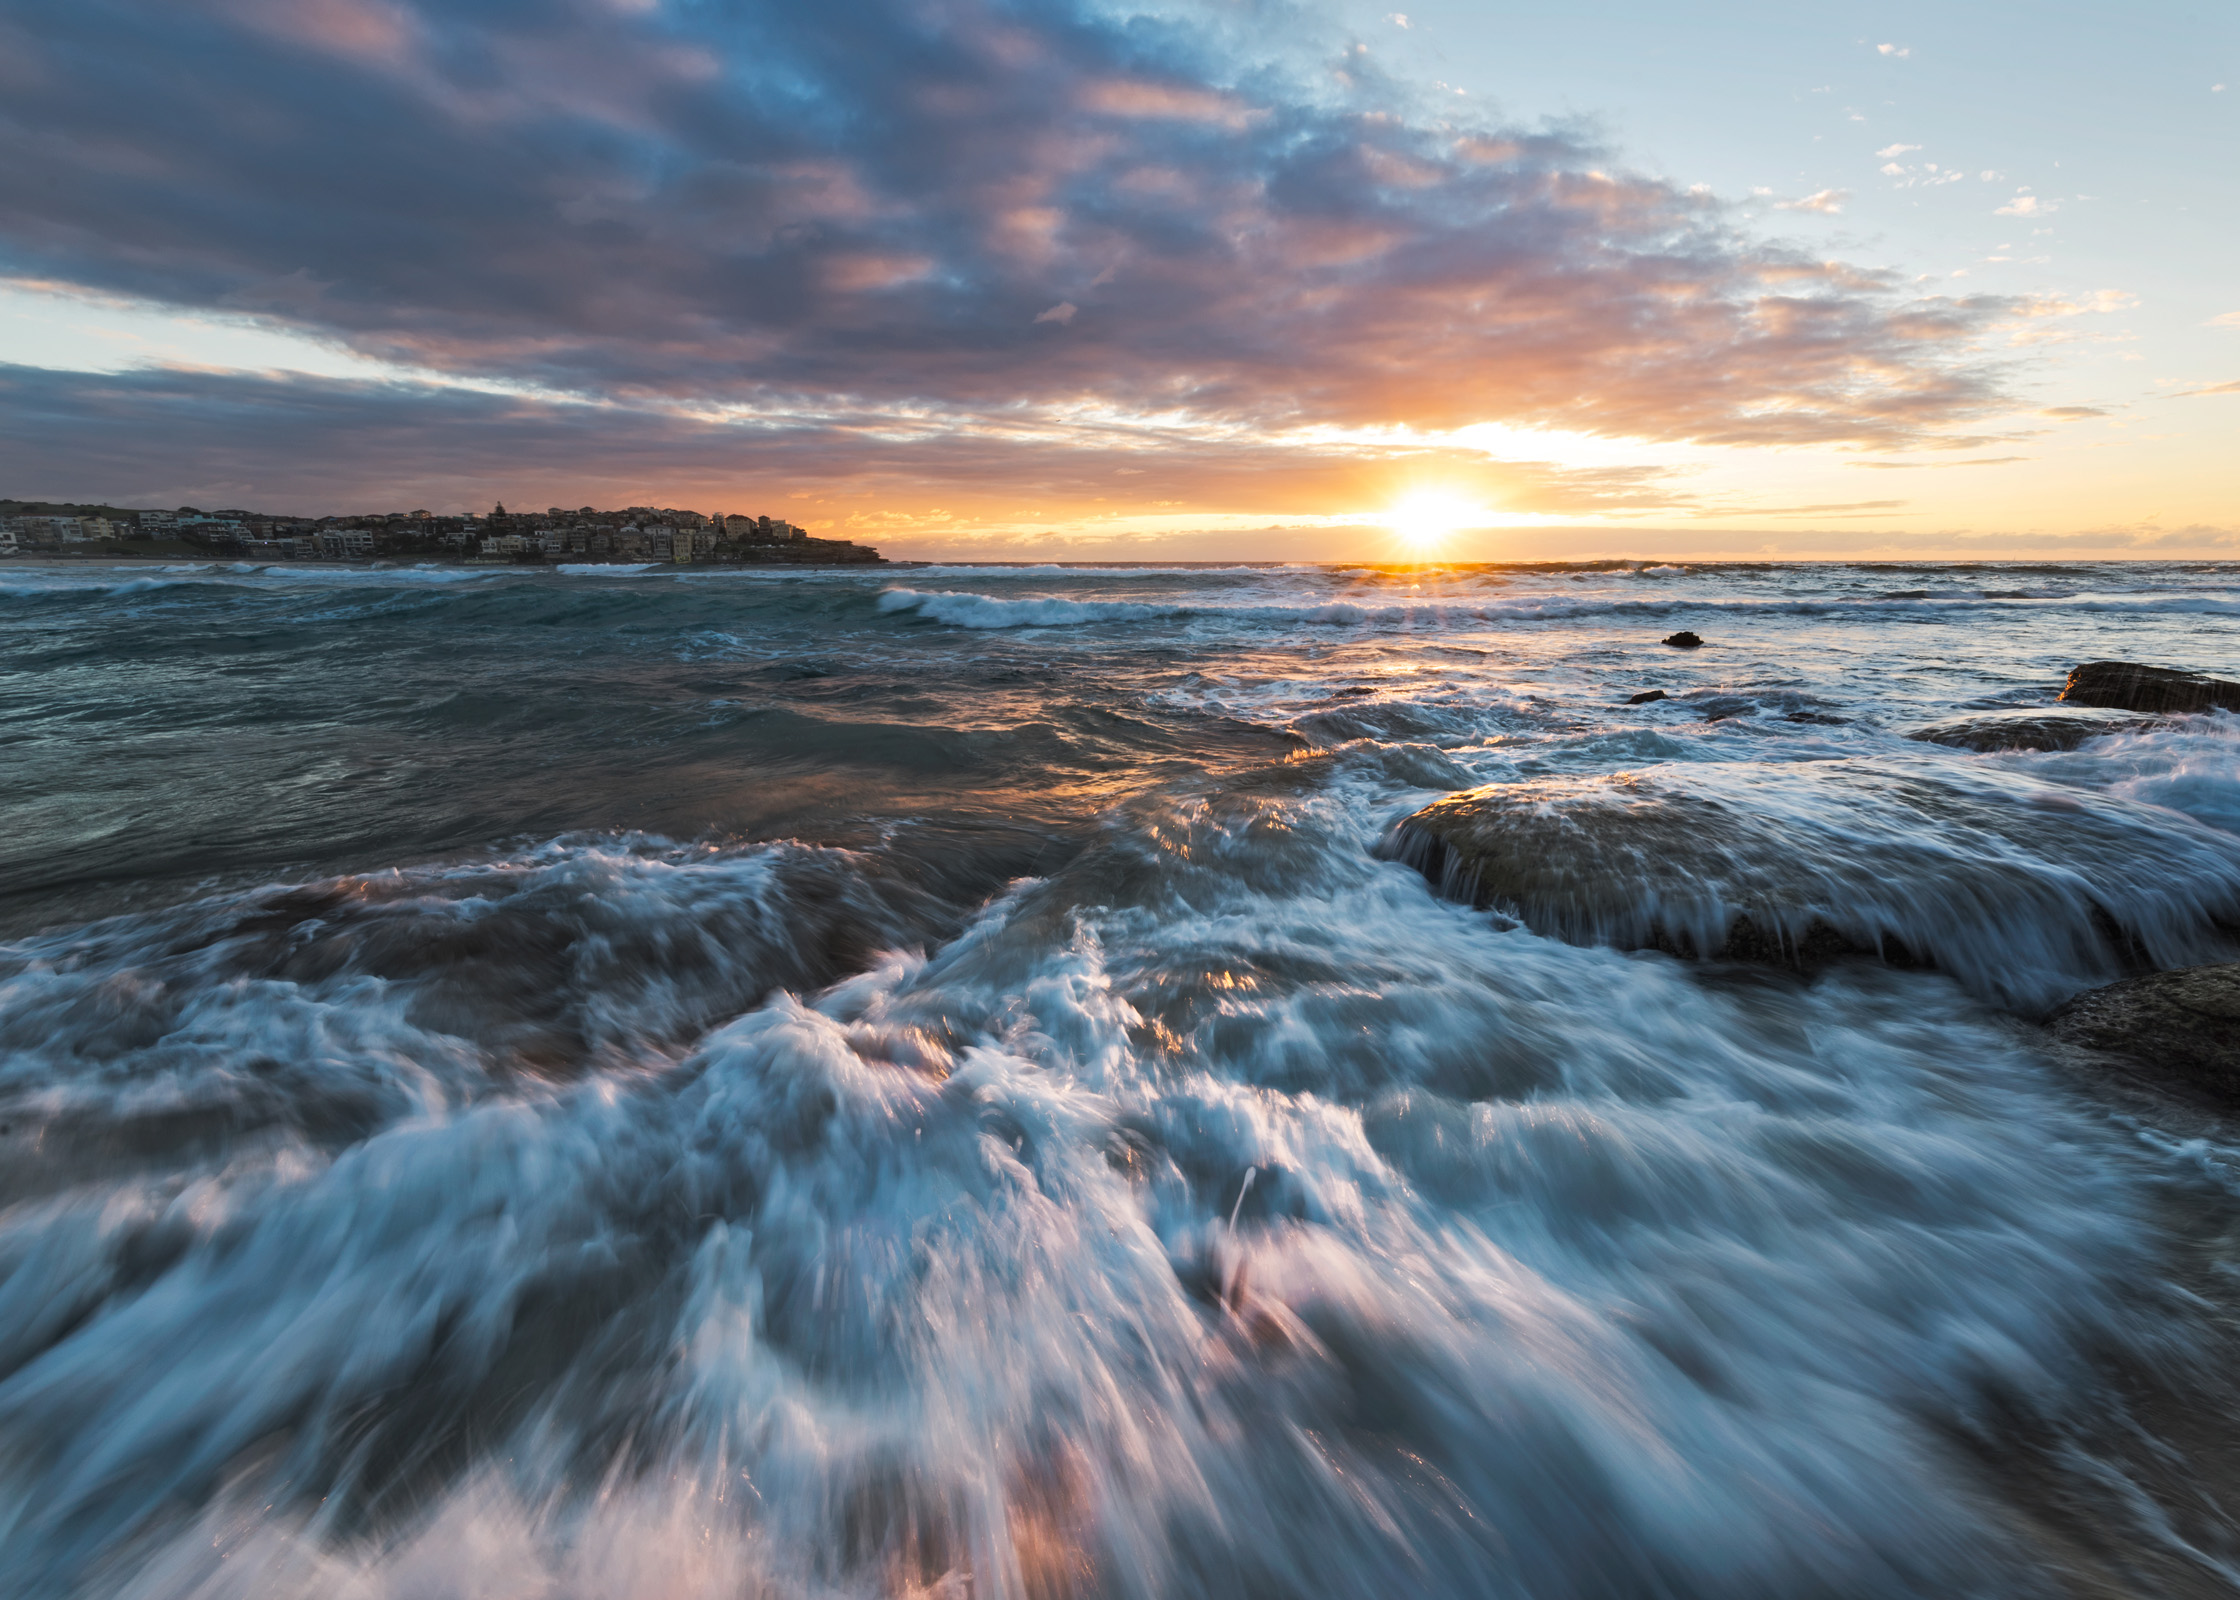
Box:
0;0;2003;444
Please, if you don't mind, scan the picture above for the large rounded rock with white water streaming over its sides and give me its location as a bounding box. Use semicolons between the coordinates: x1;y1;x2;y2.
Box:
1384;755;2240;1011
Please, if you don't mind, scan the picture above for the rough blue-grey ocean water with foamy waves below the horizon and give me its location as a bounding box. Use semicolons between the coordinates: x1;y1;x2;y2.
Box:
0;551;2240;1600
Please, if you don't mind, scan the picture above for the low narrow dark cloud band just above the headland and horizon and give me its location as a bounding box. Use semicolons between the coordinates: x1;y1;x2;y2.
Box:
0;365;1684;519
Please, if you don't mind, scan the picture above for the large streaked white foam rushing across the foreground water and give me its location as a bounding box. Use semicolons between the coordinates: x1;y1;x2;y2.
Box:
0;807;2146;1596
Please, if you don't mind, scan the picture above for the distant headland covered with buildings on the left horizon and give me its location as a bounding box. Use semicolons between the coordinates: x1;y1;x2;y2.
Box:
0;500;885;567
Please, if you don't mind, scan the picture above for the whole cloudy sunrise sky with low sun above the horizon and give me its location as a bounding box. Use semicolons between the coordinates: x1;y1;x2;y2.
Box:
0;0;2240;560
